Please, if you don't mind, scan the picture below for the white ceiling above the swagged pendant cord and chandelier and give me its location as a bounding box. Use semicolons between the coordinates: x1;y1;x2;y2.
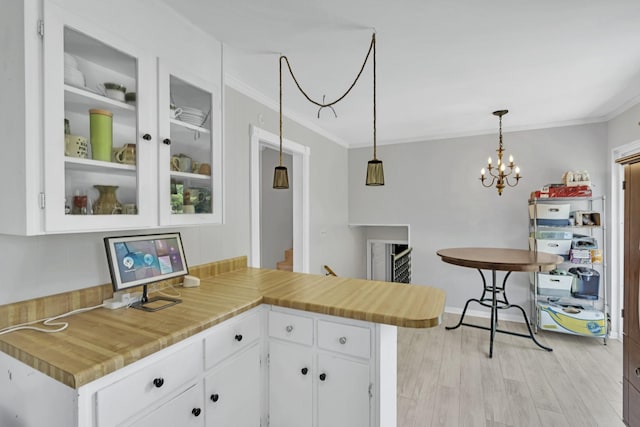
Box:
163;0;640;147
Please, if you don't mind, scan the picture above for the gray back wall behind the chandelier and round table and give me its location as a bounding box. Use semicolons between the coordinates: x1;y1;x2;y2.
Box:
349;124;607;316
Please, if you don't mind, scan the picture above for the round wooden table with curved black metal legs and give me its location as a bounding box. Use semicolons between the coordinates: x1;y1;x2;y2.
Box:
436;248;564;357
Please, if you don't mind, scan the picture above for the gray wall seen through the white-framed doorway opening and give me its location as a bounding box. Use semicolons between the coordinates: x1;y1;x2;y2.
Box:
260;148;295;269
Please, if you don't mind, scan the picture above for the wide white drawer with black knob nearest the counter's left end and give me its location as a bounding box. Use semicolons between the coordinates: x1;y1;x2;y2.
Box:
96;342;202;427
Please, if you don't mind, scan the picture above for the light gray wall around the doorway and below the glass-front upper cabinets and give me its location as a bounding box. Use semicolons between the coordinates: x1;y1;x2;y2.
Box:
0;88;365;304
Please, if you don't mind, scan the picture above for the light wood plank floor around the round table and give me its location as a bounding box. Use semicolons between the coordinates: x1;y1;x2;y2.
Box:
398;314;623;427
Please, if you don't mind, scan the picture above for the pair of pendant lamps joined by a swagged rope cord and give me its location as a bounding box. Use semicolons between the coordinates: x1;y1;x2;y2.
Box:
273;32;384;189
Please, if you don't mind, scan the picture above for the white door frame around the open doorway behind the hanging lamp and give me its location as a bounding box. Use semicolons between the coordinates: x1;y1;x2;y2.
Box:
249;125;311;273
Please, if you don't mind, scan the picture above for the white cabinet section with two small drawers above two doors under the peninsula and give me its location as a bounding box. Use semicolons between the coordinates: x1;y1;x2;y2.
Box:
269;309;376;427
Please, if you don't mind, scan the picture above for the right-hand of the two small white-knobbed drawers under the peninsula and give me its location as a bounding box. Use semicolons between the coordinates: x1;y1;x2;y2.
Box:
318;320;371;359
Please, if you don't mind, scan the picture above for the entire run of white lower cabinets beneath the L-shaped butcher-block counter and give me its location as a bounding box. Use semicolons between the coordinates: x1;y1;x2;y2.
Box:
0;305;397;427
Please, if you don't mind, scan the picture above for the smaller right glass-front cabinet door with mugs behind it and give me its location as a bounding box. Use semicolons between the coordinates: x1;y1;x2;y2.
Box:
158;60;222;225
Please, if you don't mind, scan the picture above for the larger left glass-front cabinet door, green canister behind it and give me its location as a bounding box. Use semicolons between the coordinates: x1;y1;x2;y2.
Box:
42;2;158;232
